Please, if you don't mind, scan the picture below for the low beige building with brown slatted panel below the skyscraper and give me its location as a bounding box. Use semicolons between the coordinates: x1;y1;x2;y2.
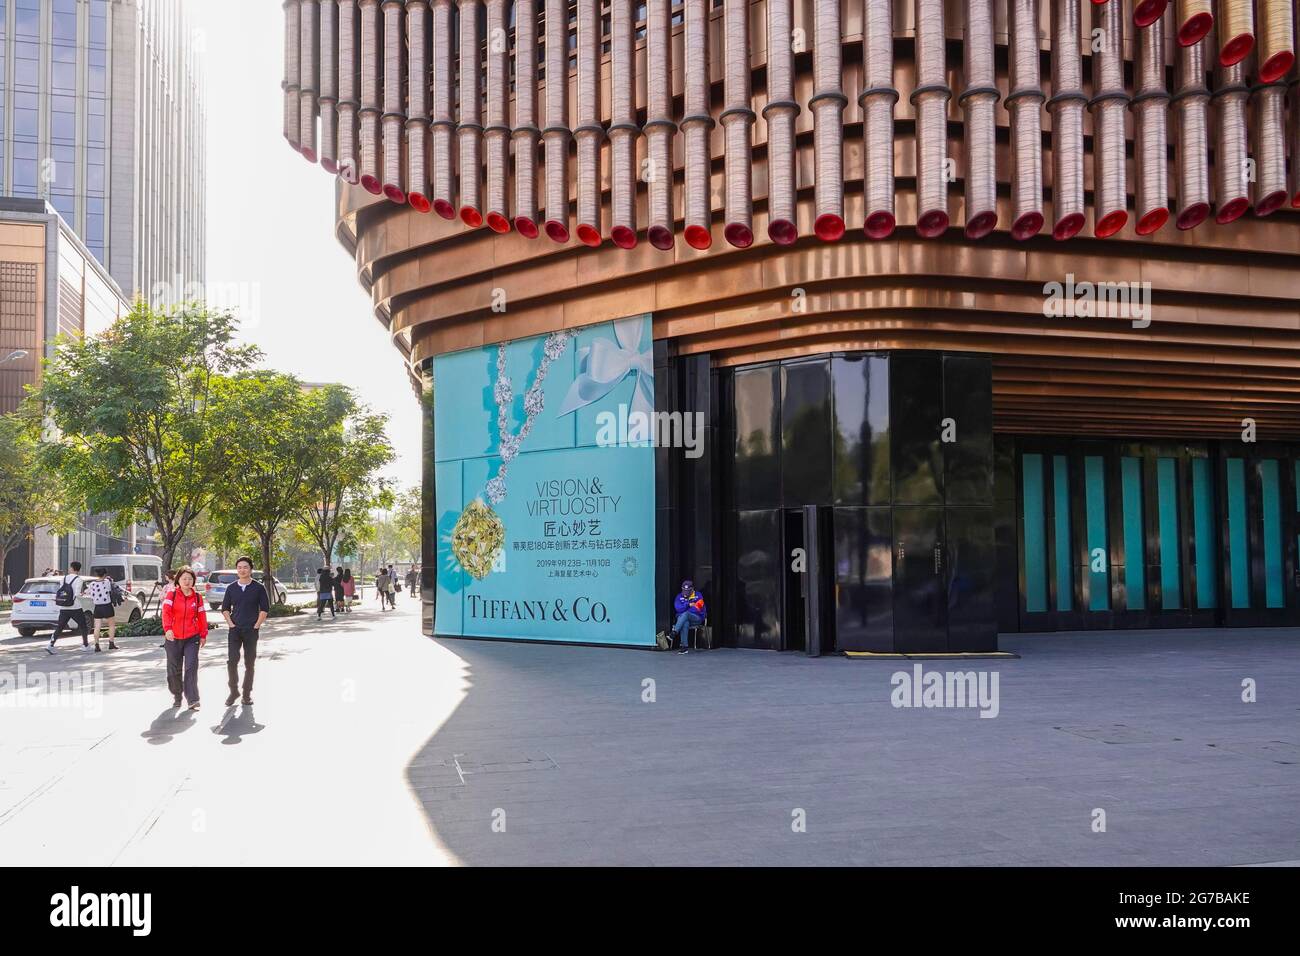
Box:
0;198;130;585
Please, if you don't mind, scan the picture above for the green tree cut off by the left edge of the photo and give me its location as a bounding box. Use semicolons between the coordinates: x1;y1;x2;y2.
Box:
0;414;77;574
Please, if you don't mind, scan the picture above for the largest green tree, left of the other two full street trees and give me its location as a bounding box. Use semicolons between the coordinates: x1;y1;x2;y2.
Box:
33;302;260;567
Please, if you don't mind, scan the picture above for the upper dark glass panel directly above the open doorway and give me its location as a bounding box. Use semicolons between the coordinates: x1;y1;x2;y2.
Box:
781;359;831;507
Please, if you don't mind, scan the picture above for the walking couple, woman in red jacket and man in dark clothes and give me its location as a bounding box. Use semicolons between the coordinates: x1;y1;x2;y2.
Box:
163;558;270;710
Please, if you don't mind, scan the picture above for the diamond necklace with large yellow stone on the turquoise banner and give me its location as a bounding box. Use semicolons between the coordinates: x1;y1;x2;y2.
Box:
451;330;572;580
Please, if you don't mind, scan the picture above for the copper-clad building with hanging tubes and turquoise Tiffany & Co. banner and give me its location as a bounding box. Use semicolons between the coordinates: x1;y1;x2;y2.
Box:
292;0;1300;653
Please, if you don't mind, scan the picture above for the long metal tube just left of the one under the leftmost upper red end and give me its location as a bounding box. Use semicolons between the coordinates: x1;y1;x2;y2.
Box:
1089;0;1128;239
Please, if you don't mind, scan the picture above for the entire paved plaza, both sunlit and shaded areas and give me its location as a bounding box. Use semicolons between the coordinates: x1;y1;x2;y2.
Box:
0;608;1300;866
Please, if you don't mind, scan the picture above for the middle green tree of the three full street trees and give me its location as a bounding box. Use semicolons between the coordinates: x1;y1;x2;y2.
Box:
212;372;334;593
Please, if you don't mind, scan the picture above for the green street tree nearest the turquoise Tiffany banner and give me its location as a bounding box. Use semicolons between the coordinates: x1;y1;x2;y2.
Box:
296;385;394;564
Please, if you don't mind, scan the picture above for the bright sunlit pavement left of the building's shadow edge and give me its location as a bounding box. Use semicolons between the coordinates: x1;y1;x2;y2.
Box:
0;594;463;866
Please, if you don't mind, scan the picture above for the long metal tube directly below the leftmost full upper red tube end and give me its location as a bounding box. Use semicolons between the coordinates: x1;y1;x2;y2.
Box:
1132;9;1169;235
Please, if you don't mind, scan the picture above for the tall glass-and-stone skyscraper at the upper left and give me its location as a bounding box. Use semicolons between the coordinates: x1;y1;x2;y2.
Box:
0;0;207;302
